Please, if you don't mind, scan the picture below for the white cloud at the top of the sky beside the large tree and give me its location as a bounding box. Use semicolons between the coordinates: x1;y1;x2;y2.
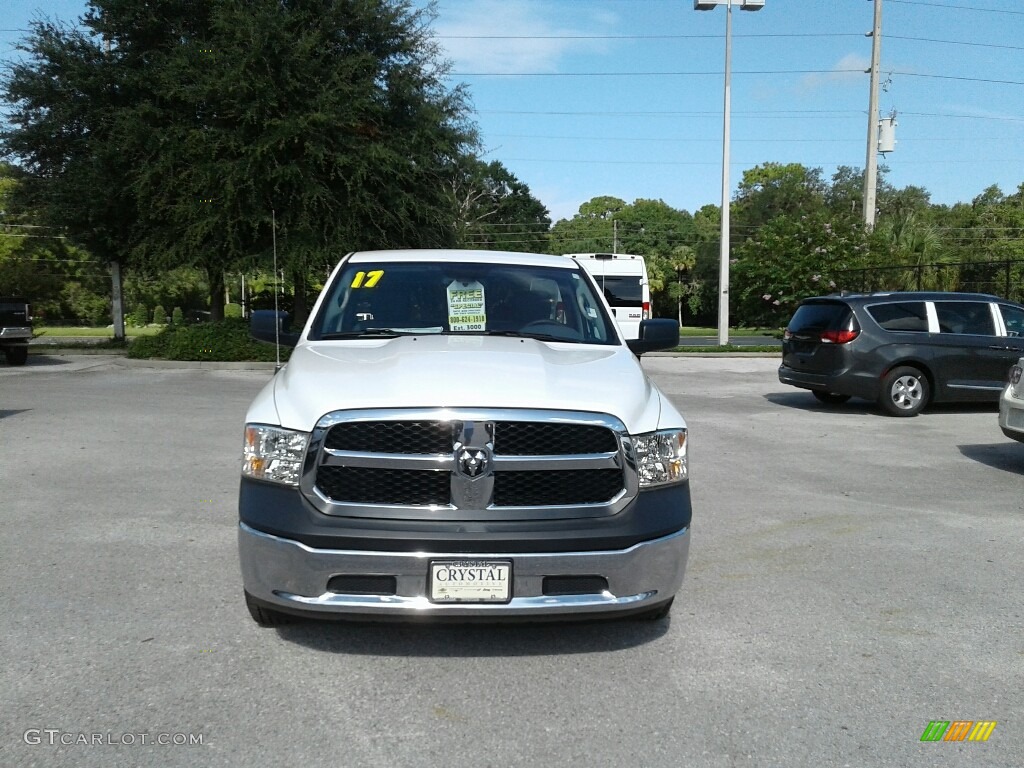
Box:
434;0;614;73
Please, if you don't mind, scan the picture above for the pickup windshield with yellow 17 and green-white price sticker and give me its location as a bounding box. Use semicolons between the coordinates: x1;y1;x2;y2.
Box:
309;261;617;344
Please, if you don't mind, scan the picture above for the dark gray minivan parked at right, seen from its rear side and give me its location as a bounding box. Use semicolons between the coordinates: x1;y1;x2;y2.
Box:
778;292;1024;416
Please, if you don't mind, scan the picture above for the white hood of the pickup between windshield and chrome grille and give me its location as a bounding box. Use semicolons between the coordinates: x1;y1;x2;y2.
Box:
254;335;667;434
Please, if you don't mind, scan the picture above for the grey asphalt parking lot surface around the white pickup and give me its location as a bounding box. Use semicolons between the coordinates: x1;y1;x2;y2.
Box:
0;355;1024;768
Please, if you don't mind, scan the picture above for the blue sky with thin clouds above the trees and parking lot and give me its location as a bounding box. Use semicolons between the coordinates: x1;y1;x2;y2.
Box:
0;0;1024;220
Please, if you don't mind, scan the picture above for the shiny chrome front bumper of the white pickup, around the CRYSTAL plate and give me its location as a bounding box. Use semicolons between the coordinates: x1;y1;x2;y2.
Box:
239;523;690;618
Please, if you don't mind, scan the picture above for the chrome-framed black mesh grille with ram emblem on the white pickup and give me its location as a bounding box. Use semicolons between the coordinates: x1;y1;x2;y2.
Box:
299;409;639;521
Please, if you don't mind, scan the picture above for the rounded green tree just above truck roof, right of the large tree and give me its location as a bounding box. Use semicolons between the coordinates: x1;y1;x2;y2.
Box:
450;156;551;253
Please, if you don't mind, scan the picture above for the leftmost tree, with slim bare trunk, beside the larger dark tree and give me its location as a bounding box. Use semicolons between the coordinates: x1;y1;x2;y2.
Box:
0;12;148;338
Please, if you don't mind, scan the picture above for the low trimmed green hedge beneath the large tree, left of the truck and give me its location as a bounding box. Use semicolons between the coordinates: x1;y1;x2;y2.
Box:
128;319;291;361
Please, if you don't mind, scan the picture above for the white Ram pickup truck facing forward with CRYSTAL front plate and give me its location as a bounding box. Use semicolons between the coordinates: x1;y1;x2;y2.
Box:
239;250;691;626
